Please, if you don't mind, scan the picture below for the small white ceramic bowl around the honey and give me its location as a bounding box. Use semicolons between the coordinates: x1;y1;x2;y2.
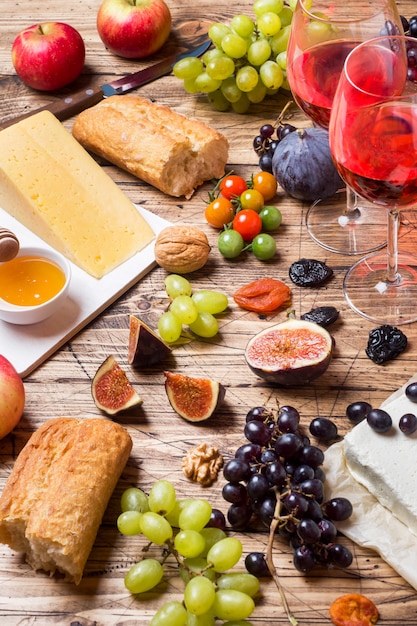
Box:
0;246;71;325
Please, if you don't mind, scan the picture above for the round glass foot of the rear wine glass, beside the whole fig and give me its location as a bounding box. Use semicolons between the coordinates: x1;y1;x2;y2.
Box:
306;190;387;255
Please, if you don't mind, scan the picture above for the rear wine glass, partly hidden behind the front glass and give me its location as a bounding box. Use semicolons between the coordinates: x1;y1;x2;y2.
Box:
287;0;404;255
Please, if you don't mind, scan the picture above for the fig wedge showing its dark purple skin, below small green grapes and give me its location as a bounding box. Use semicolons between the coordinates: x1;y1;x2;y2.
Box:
127;315;171;368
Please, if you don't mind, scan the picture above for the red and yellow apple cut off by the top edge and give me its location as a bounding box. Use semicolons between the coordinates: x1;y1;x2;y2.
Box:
97;0;171;59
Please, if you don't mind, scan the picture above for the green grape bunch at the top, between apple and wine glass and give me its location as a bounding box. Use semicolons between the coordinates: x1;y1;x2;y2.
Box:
173;0;294;113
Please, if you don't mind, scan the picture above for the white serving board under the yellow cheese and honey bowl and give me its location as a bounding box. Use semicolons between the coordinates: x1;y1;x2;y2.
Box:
0;206;170;377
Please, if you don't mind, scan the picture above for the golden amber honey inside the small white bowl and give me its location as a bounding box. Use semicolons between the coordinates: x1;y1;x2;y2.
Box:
0;255;66;306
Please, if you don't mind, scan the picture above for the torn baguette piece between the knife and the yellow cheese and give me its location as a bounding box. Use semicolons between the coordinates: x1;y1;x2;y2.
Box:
72;96;229;198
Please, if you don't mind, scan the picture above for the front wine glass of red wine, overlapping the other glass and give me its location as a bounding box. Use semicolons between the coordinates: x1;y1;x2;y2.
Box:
329;36;417;325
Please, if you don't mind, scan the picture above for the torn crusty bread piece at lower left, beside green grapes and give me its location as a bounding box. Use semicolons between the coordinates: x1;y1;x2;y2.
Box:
0;417;132;584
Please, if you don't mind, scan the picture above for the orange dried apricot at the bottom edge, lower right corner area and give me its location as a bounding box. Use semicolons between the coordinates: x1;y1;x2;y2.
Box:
329;593;379;626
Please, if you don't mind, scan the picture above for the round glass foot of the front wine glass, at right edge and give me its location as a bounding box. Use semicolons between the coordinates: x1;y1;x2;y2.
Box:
343;252;417;326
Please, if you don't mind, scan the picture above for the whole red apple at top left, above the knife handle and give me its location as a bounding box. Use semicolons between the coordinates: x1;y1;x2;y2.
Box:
12;22;85;91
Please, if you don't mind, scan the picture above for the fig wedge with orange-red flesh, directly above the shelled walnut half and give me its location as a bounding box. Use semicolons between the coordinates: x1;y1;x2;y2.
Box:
164;372;226;422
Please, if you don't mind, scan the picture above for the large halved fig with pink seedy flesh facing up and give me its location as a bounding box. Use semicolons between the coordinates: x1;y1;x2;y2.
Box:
245;319;334;387
